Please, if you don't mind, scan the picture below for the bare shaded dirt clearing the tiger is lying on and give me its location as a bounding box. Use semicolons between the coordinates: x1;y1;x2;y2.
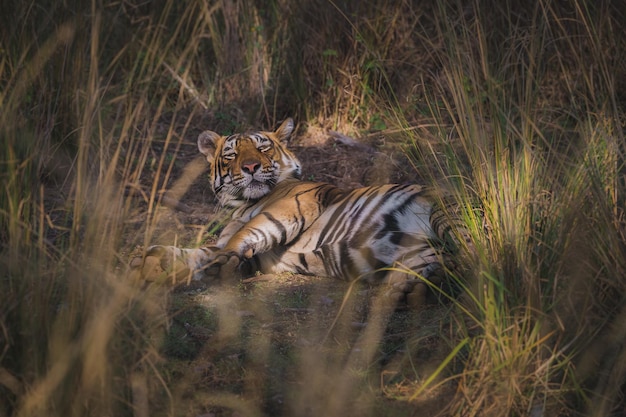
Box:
128;122;454;417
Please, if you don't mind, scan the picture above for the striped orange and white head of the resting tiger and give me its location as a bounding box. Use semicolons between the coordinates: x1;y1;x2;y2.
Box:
198;118;301;207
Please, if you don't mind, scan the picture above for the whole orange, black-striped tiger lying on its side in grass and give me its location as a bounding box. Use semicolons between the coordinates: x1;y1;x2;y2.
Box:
135;118;468;305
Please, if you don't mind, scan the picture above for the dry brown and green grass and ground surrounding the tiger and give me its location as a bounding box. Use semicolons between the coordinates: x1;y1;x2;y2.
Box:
0;0;626;417
